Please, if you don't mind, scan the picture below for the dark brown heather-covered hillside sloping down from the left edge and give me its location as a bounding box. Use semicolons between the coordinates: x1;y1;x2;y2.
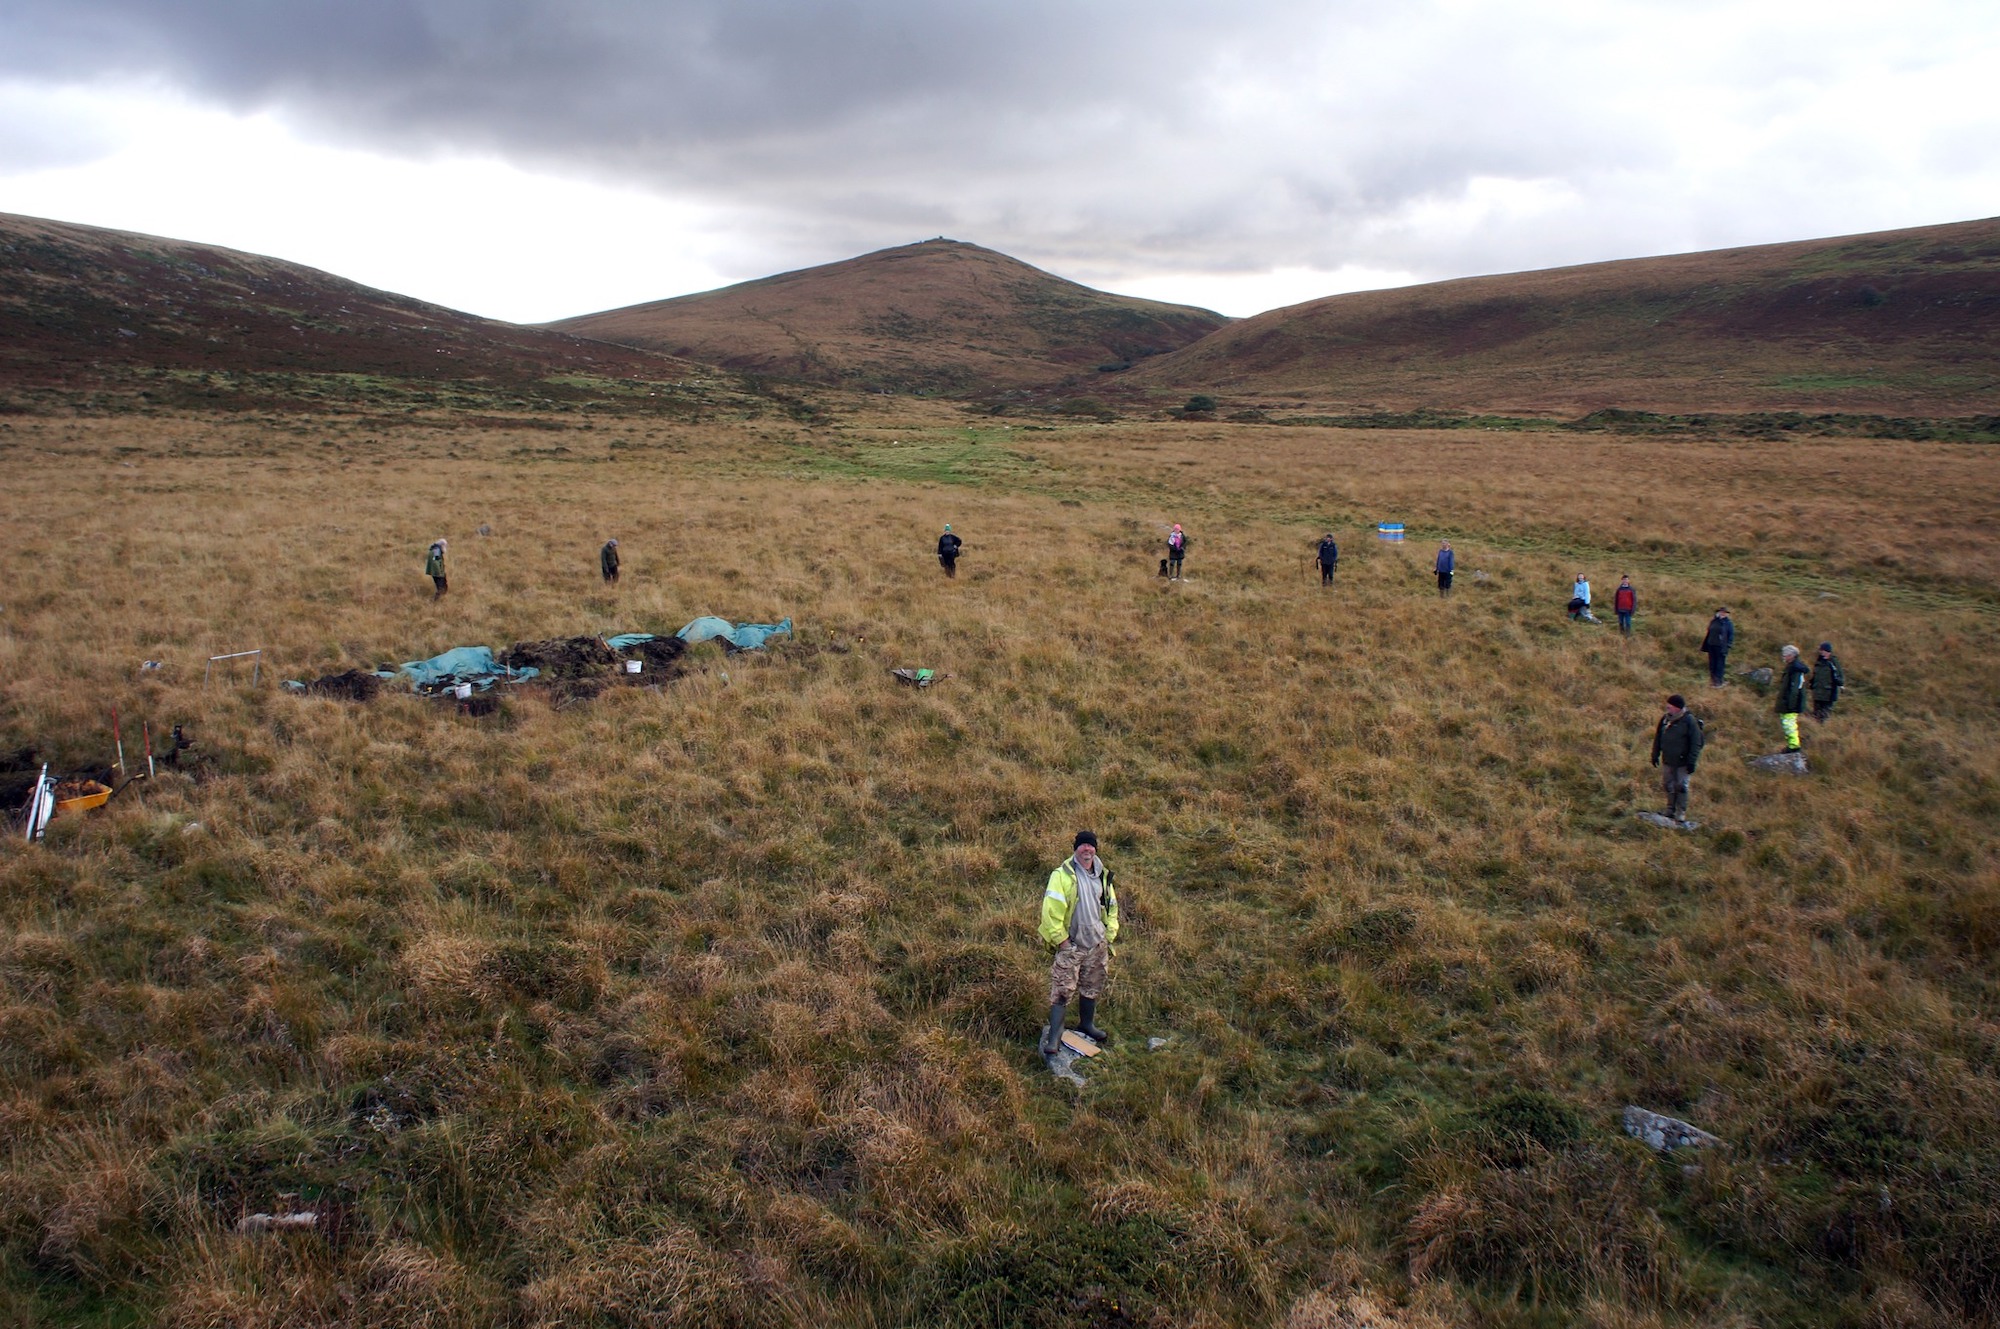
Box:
0;214;712;404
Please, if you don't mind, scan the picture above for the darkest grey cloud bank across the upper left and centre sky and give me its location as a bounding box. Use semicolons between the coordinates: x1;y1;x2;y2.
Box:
0;0;1224;166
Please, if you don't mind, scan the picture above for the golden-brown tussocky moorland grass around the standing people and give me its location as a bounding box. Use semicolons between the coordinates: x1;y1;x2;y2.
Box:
0;404;2000;1325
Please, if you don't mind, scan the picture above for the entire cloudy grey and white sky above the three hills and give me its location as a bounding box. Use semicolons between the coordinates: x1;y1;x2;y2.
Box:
0;0;2000;320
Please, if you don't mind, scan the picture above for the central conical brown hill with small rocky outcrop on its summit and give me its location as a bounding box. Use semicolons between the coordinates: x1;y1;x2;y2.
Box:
548;238;1228;394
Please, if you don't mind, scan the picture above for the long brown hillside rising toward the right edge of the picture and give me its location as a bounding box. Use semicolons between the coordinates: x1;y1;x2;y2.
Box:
1118;218;2000;414
